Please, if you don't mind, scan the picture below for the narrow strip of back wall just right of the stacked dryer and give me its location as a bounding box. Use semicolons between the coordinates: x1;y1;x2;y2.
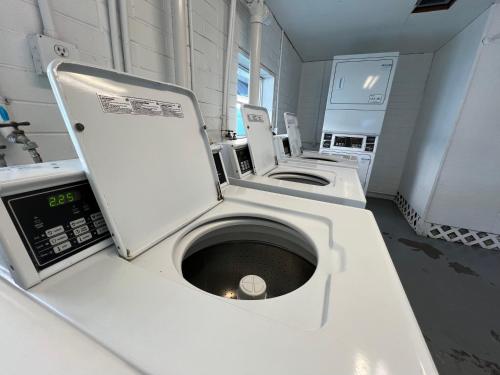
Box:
368;53;433;196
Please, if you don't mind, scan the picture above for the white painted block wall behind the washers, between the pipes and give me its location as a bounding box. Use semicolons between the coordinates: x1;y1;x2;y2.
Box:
0;0;302;164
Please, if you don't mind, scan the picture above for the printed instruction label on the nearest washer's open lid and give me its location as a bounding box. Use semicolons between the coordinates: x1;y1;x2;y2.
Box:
97;94;184;118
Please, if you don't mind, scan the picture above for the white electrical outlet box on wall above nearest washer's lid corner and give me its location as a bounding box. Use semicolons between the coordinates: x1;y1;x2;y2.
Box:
28;34;80;74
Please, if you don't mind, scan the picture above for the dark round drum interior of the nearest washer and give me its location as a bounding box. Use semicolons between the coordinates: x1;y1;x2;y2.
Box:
182;220;316;299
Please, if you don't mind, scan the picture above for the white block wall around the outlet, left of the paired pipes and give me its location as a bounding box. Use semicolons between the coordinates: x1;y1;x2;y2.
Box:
0;0;111;164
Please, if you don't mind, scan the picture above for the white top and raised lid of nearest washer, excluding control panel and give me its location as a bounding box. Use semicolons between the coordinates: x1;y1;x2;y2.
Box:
34;63;437;375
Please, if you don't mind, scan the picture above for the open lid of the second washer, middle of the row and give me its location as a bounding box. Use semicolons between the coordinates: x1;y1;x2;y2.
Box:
241;104;278;176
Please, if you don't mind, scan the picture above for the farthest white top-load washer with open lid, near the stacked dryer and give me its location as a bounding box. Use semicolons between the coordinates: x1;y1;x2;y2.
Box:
282;112;358;168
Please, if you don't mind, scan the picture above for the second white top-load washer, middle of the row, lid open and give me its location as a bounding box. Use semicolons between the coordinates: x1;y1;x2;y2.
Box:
222;105;366;208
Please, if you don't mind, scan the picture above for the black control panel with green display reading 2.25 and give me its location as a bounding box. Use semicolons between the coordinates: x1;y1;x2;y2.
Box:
2;180;110;270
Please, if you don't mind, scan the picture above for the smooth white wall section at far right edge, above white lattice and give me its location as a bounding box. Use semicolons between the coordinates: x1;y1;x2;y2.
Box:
426;5;500;233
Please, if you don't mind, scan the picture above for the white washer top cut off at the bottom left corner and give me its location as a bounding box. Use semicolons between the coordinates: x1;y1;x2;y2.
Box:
0;271;138;375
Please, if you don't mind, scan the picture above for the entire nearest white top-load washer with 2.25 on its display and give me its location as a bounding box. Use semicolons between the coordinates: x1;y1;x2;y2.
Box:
0;61;437;375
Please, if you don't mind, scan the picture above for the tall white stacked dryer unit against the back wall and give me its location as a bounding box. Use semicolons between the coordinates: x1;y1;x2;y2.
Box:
320;52;399;192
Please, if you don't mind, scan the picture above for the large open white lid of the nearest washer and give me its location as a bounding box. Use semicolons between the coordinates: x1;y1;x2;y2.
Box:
48;60;222;258
